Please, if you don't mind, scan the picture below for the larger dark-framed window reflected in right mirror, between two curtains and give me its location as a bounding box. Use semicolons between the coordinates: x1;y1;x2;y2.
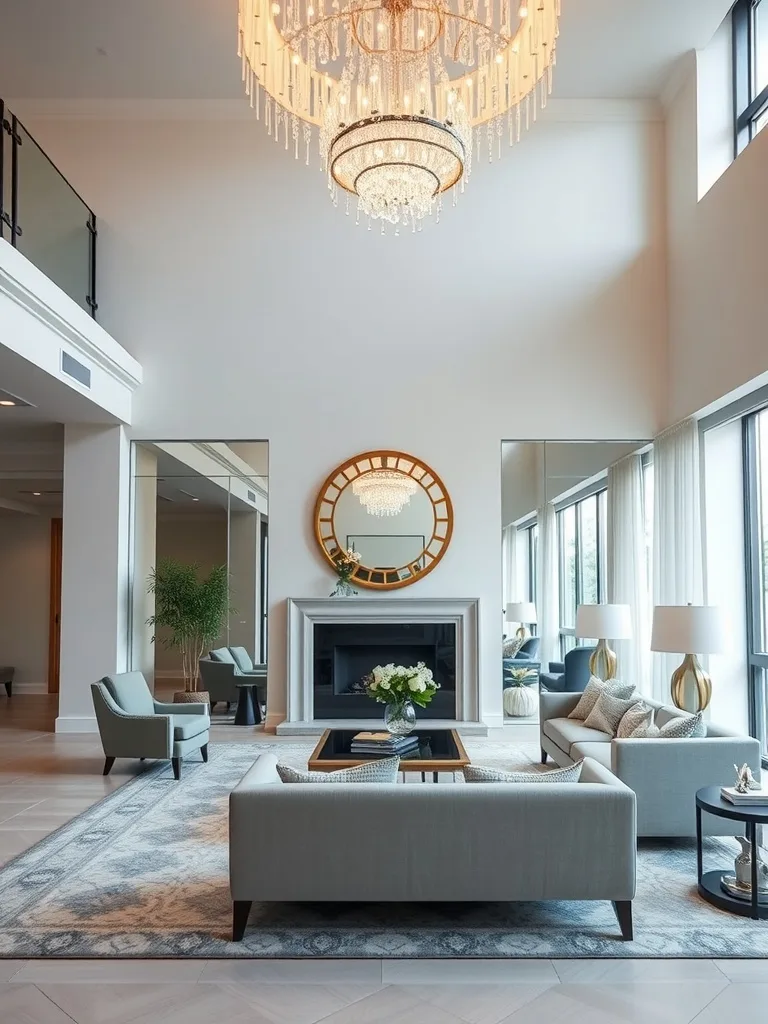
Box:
557;489;607;655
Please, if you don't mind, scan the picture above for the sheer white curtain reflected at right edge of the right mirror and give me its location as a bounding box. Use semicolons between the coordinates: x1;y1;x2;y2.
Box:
607;455;653;695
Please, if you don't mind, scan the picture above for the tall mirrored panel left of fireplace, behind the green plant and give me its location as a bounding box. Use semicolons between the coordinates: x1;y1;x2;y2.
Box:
129;441;269;704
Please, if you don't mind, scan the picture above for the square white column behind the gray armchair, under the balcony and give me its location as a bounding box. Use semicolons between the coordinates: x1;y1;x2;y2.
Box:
56;424;130;732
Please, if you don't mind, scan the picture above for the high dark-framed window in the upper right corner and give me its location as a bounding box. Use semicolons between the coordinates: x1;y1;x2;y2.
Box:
733;0;768;155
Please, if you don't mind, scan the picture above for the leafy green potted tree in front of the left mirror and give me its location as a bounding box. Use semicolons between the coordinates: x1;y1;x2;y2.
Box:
147;558;229;703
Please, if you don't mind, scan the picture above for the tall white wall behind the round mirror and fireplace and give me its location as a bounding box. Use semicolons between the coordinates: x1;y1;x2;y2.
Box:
24;102;666;724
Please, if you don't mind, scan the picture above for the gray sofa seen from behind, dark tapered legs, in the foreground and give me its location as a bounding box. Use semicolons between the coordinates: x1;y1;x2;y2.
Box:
229;754;636;941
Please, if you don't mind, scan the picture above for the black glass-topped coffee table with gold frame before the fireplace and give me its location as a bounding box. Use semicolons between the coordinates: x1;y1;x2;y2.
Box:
307;729;470;782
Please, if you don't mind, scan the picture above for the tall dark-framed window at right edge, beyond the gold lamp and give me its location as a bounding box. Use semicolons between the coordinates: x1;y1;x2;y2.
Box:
743;409;768;755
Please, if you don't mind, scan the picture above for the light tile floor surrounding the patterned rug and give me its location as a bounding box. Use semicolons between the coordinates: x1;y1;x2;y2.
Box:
0;694;768;1024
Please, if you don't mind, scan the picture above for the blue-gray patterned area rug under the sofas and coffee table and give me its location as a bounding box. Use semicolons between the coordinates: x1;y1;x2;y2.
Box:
0;740;768;958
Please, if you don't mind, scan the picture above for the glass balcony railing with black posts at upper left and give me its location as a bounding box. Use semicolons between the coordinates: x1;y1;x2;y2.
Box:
0;99;96;316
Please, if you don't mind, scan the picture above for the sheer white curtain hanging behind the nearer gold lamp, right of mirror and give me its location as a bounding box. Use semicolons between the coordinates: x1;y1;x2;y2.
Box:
652;420;703;703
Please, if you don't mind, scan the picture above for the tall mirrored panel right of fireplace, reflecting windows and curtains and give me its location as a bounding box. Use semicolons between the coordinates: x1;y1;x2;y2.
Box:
502;441;653;720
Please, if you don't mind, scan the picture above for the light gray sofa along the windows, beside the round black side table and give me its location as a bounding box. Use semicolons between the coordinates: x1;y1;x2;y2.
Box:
540;693;761;837
